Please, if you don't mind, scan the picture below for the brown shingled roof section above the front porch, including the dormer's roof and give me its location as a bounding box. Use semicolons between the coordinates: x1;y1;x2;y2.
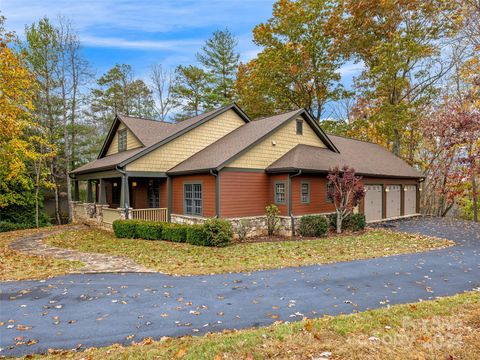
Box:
71;103;250;174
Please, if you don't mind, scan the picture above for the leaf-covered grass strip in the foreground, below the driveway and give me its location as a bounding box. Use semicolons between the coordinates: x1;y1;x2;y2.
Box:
23;292;480;360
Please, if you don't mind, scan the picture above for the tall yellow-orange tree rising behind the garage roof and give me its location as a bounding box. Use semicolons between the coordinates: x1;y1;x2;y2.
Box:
337;0;458;160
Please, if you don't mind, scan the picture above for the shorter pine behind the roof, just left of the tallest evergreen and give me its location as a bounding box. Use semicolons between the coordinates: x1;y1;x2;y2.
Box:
171;65;212;121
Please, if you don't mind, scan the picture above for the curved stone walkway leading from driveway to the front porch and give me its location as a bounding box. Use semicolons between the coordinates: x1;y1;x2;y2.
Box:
10;225;155;274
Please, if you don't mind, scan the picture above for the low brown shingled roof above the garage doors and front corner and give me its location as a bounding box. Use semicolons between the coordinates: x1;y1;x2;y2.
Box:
266;135;423;178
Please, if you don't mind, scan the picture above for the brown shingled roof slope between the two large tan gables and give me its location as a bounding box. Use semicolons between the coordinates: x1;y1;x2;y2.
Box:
167;109;338;174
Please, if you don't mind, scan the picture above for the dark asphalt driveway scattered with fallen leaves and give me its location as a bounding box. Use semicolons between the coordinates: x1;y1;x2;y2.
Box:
0;218;480;355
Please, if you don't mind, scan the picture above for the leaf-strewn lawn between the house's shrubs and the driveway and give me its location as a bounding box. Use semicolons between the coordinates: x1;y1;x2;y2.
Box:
47;229;454;275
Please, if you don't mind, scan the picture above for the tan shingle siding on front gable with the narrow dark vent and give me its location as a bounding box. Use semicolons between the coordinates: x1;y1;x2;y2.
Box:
228;119;326;169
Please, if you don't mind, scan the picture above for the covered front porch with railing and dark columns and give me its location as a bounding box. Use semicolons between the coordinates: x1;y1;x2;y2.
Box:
72;170;169;224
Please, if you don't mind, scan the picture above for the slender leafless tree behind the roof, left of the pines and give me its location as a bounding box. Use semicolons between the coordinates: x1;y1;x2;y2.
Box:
150;64;175;121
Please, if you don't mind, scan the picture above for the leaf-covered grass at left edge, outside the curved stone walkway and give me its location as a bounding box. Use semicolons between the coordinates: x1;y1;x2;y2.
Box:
0;226;83;281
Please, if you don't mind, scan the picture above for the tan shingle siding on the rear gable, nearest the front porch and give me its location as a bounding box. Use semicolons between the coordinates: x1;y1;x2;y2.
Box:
127;110;245;172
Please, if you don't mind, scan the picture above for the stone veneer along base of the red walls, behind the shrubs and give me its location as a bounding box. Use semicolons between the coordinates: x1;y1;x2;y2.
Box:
171;213;334;237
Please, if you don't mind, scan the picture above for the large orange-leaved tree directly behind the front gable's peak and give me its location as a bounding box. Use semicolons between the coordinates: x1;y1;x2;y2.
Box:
237;0;344;121
